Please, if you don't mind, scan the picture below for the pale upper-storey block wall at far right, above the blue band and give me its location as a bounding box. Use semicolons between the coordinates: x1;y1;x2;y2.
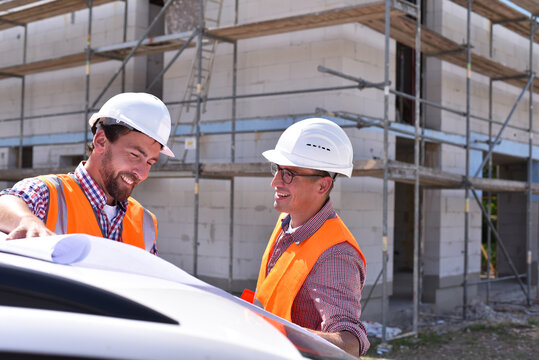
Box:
427;0;539;142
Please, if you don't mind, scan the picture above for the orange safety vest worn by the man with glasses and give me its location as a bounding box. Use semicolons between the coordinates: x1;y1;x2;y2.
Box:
255;214;365;321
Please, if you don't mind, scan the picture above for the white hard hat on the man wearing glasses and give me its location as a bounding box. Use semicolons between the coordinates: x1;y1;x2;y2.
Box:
262;118;354;177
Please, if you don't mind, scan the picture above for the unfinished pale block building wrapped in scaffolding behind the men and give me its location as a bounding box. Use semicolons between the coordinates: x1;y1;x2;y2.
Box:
0;0;539;327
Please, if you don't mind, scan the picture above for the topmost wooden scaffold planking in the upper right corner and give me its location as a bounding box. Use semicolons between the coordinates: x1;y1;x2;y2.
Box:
451;0;539;43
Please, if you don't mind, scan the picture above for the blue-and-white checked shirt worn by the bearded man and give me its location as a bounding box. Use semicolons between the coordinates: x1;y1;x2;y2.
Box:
0;162;157;255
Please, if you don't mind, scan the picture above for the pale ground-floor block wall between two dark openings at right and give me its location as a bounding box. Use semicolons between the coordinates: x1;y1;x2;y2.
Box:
423;145;481;311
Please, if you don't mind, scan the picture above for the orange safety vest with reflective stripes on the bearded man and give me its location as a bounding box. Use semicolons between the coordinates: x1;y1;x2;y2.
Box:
39;174;157;251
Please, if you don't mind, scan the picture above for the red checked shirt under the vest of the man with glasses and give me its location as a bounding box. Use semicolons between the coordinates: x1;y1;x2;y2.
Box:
267;200;370;355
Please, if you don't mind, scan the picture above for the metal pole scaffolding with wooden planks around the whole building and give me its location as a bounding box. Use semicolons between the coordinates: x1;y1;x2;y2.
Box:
0;0;539;341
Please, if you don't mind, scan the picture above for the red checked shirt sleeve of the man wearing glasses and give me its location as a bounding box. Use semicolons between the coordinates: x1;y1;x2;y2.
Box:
295;243;370;355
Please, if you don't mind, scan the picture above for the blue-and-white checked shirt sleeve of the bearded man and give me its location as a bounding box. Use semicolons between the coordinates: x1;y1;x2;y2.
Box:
0;178;49;221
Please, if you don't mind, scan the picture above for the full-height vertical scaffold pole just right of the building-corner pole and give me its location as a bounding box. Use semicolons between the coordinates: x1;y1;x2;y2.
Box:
412;0;421;334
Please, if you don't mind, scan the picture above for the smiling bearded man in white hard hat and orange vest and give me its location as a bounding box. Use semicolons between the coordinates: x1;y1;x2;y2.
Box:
0;93;174;254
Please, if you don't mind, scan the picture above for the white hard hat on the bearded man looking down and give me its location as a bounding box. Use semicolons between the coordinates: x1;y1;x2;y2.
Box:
88;93;174;156
